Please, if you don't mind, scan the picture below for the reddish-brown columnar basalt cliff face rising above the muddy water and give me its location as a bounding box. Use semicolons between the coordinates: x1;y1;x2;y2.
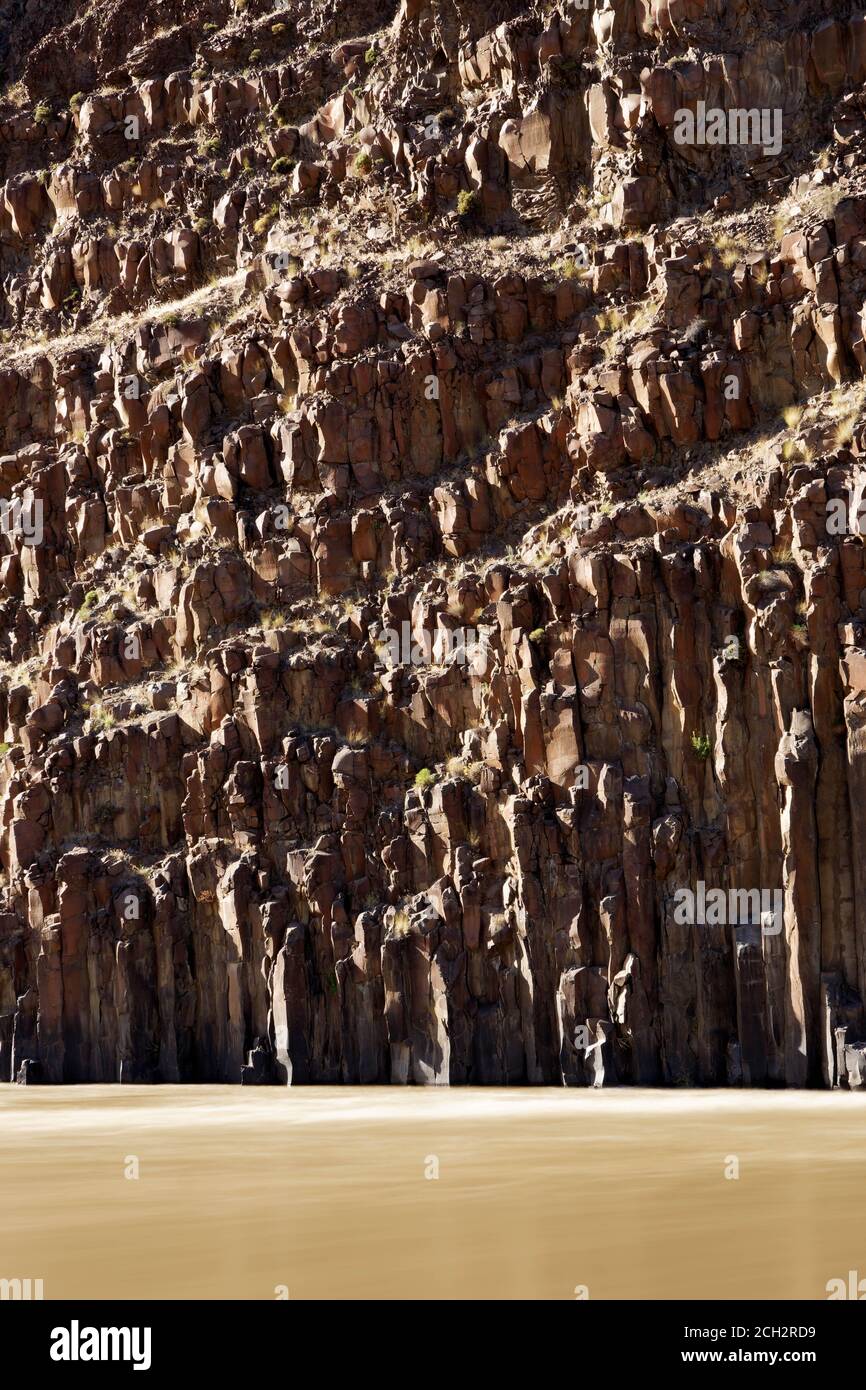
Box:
0;0;866;1088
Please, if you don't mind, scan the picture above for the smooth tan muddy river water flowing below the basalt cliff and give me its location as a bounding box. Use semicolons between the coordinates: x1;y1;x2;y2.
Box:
0;1086;866;1300
